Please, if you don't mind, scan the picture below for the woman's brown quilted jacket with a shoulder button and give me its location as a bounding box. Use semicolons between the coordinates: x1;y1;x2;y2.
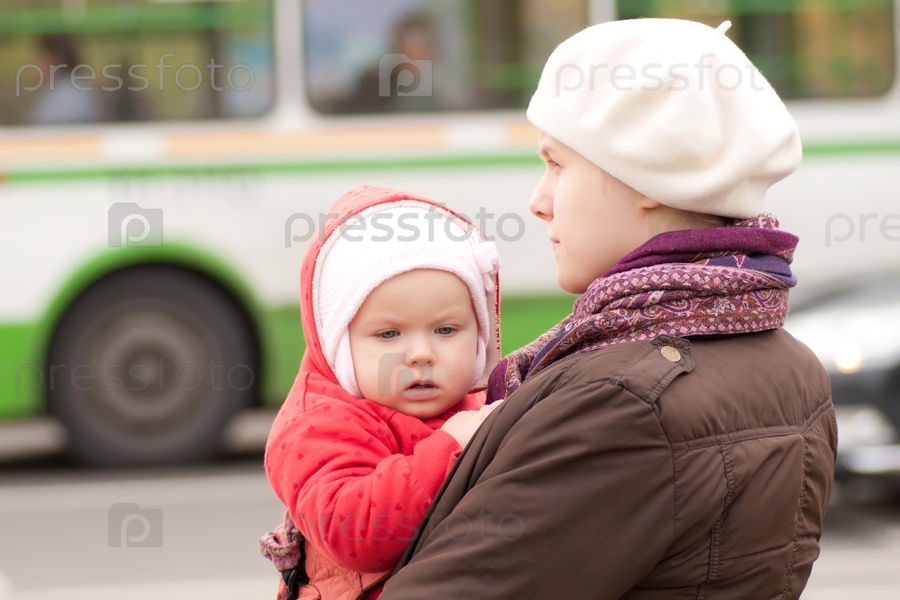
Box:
381;330;837;600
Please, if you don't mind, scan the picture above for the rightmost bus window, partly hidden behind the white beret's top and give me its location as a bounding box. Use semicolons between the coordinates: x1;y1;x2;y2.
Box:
617;0;896;99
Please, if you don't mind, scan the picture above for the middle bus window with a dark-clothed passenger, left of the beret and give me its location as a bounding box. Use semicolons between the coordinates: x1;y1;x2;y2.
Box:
303;0;588;113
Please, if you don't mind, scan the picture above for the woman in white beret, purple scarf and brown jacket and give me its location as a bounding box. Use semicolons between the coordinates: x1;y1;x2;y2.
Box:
381;19;837;600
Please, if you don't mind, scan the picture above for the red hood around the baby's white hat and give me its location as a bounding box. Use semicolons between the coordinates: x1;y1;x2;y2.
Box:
300;185;500;389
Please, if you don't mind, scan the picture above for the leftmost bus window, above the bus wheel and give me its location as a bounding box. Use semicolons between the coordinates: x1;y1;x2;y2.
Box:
0;0;274;125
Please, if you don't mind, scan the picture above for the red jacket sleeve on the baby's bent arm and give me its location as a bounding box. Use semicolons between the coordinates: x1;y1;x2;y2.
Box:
266;403;461;573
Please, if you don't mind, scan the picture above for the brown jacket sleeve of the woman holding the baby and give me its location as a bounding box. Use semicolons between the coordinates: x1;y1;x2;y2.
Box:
381;376;675;600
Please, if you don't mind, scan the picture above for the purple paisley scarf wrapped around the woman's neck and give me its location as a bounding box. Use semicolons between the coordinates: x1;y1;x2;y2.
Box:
488;213;798;402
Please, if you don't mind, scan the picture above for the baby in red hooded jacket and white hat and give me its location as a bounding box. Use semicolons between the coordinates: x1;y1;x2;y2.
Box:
260;186;500;600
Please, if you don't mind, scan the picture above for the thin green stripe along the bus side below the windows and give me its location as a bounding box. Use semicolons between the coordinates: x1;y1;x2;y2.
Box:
0;141;900;183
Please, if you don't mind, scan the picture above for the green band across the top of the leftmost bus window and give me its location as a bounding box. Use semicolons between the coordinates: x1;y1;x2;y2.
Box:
0;2;272;35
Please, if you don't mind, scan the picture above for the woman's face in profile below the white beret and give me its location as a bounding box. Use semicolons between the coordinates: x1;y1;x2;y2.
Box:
528;132;660;294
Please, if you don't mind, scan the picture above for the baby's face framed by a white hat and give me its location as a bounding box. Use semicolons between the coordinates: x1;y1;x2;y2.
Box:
350;269;478;419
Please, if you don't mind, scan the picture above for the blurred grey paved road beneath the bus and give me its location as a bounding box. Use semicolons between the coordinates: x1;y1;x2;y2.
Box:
0;455;900;600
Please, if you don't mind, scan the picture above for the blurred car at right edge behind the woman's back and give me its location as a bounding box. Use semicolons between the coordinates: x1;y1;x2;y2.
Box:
785;273;900;477
